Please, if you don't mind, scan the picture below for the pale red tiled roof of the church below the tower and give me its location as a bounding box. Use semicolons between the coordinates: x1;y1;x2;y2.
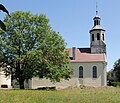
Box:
67;48;106;62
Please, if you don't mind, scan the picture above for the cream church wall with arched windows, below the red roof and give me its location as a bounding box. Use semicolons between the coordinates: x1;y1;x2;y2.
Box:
29;62;106;89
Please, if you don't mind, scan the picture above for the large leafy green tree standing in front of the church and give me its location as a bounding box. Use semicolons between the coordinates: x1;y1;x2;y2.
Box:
0;11;72;89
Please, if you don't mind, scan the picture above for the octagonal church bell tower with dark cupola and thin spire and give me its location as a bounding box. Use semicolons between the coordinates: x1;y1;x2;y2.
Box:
89;5;106;53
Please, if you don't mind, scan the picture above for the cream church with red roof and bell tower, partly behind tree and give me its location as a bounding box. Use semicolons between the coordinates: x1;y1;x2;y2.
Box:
29;10;107;89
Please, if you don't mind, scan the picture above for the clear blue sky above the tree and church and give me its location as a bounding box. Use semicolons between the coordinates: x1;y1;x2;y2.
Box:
0;0;120;70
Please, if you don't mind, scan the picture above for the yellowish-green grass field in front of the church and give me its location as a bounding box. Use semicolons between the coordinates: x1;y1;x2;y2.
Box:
0;88;120;103
